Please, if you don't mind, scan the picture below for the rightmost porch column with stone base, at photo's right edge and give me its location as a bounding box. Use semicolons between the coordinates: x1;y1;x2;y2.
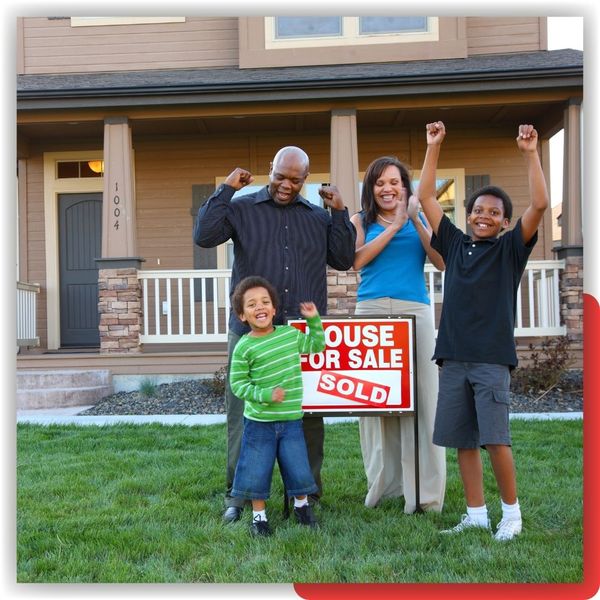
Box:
556;98;583;355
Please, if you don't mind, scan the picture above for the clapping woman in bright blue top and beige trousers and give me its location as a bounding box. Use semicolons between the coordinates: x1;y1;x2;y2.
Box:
351;156;446;514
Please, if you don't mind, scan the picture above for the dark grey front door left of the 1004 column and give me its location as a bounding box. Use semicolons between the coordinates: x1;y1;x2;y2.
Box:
58;193;102;348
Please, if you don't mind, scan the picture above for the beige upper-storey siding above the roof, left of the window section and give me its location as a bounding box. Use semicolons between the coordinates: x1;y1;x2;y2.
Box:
22;17;238;74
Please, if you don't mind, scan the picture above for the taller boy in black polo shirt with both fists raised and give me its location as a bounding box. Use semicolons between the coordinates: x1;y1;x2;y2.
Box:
419;121;548;540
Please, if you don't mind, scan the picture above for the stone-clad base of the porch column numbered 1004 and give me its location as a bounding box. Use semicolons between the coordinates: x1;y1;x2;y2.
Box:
98;267;142;353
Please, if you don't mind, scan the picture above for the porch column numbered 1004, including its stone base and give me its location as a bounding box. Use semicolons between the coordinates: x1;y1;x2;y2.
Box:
96;117;144;353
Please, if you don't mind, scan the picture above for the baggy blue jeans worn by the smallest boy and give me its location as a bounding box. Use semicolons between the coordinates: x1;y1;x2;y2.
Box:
231;417;318;500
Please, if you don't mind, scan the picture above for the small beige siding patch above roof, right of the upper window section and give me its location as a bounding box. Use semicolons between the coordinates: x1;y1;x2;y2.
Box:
467;17;546;56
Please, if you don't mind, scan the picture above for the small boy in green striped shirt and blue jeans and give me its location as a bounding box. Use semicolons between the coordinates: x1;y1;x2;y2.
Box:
229;276;325;536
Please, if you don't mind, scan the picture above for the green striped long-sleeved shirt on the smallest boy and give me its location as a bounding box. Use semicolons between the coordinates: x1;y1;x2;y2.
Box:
229;315;325;421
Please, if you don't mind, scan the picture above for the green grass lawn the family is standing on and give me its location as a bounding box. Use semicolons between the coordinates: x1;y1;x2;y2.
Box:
17;421;583;583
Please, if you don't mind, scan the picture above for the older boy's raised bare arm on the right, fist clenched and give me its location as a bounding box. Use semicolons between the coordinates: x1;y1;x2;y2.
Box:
517;125;549;244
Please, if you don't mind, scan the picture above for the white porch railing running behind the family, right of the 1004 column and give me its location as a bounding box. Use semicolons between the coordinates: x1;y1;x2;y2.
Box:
138;260;566;344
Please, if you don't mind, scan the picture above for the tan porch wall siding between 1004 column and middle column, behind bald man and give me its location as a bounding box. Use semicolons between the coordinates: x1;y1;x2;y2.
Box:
135;134;336;269
